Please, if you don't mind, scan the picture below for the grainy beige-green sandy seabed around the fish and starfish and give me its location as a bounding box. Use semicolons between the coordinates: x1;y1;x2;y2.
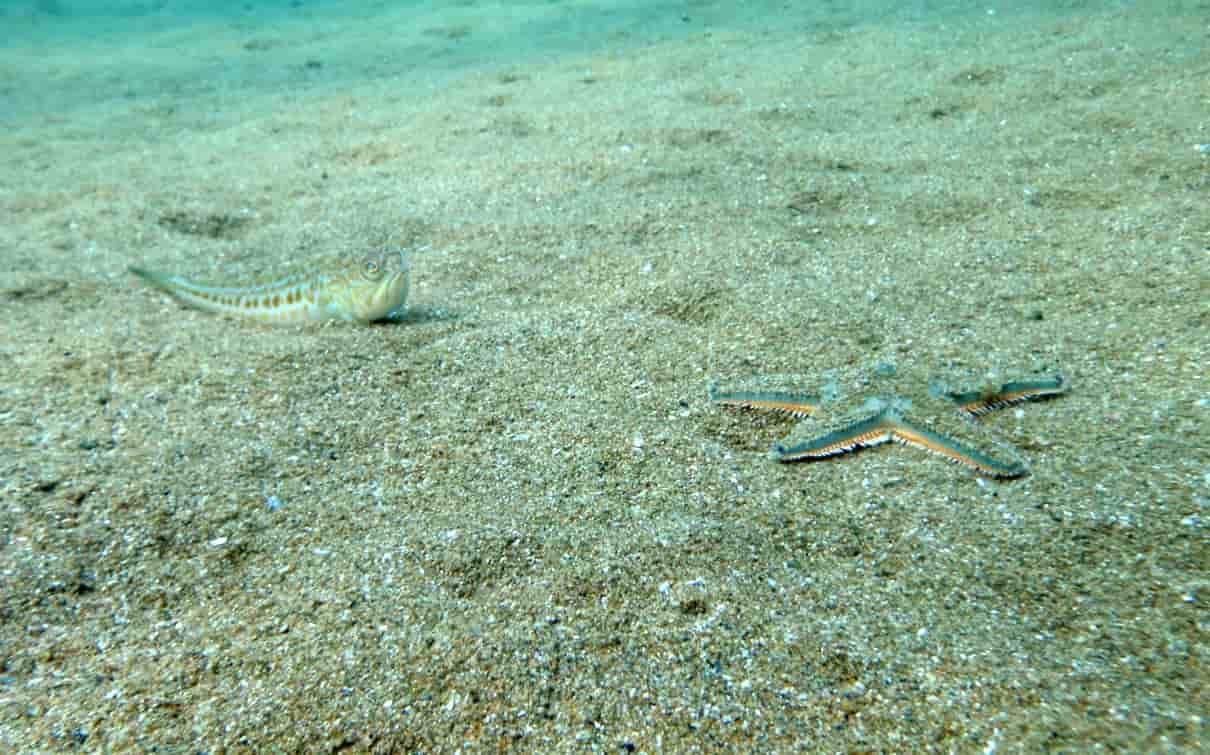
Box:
0;2;1210;753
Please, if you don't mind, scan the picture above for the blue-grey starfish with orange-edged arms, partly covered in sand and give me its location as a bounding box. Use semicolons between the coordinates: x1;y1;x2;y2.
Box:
710;364;1065;479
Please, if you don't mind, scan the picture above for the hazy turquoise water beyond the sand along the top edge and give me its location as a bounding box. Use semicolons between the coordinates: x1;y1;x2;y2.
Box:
0;0;1106;120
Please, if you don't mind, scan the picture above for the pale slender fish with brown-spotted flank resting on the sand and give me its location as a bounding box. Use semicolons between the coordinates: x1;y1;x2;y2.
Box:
129;244;411;323
